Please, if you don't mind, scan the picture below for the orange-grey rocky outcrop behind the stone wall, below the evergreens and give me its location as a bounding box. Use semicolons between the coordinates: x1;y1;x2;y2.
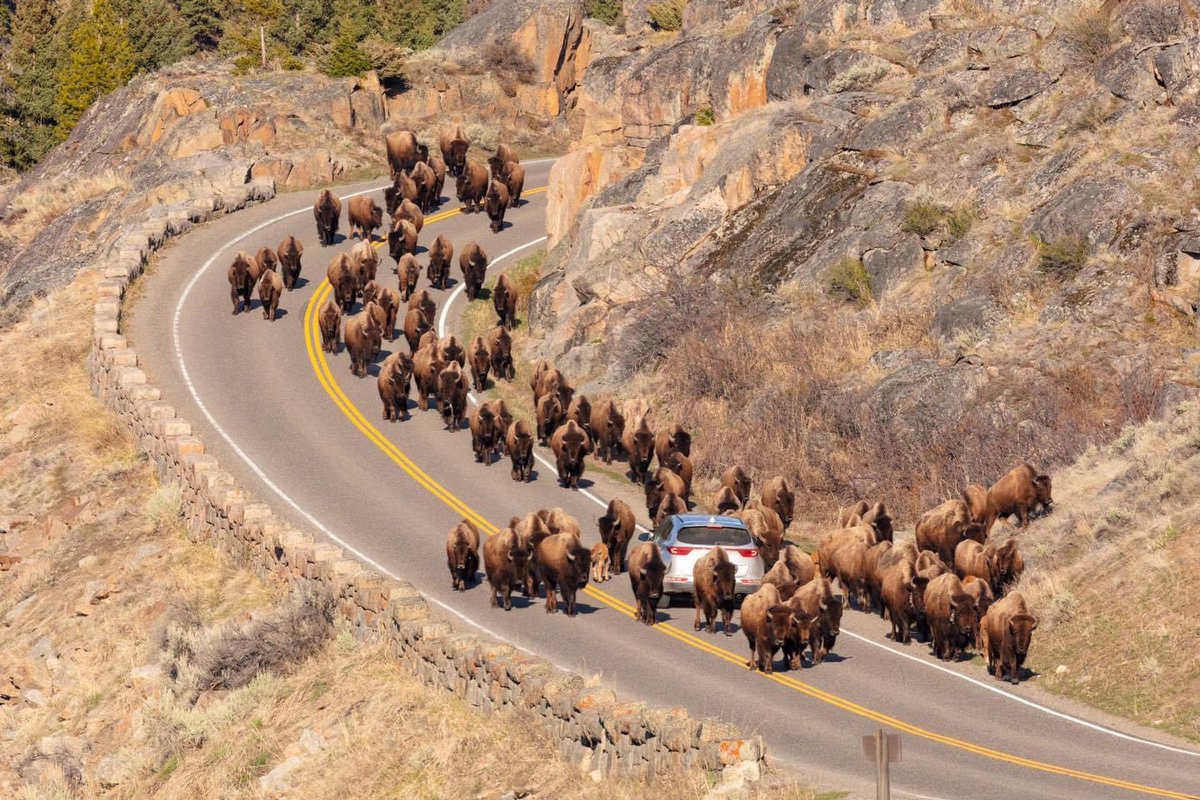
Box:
0;0;590;319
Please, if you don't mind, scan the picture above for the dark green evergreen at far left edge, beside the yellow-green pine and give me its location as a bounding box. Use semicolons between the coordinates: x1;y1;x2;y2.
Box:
0;0;60;169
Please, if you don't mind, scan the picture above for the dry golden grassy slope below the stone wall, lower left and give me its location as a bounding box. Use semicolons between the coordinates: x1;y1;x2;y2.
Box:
0;278;814;800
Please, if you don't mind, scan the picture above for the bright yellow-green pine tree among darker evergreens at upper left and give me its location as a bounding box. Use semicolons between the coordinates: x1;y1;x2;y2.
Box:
58;0;137;134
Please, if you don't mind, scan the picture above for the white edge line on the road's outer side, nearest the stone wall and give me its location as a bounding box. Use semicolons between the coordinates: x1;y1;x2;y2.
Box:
172;178;566;669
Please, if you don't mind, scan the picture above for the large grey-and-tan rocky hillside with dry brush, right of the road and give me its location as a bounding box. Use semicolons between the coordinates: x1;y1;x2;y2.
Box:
529;0;1200;518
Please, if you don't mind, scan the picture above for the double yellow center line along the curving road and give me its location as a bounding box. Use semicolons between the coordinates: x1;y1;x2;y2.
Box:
304;186;1200;800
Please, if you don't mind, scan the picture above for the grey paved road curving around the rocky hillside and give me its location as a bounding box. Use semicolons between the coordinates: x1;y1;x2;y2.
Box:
130;163;1200;800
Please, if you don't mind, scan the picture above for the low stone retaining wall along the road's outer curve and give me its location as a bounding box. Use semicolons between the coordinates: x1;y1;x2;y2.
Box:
89;173;764;781
